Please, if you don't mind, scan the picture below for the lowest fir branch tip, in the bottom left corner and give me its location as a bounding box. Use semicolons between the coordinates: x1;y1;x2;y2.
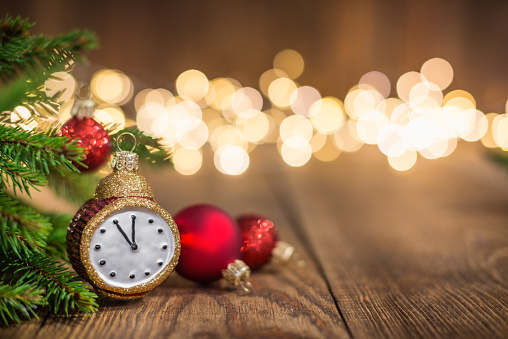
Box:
0;284;46;325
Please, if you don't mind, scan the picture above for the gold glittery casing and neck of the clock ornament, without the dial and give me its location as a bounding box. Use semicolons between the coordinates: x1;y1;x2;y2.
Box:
67;152;180;299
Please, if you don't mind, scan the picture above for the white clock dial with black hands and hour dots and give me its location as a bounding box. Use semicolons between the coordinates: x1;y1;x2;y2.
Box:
89;207;175;288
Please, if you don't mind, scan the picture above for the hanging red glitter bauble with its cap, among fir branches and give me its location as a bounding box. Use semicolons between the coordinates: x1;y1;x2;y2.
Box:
57;88;112;172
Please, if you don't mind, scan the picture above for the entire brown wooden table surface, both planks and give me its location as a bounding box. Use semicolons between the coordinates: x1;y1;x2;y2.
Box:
0;143;508;339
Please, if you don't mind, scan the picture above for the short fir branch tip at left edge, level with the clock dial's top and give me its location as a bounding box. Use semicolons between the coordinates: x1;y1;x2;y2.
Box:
0;194;52;258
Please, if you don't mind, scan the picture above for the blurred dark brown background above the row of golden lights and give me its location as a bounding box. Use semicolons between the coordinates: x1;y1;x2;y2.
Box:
5;0;508;113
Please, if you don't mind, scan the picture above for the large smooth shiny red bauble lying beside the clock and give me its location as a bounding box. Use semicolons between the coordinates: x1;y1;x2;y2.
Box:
174;205;242;283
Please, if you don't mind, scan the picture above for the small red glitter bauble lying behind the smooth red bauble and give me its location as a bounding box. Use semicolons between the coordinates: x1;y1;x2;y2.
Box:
236;215;278;269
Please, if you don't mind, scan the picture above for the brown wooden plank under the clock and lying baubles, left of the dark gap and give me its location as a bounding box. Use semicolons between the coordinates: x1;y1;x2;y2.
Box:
16;170;349;338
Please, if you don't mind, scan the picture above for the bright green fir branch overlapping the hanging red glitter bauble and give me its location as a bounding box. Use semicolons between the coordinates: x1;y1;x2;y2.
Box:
0;125;85;178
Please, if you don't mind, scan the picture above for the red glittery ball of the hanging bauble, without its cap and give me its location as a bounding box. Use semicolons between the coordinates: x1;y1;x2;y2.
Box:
58;117;112;172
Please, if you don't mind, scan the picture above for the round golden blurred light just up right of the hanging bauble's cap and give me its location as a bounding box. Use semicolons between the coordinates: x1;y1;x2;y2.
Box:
90;69;134;105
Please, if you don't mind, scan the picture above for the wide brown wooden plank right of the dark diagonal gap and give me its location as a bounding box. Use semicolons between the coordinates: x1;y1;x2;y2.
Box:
286;145;508;338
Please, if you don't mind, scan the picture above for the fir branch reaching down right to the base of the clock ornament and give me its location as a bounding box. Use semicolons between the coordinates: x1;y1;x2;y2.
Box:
0;253;98;316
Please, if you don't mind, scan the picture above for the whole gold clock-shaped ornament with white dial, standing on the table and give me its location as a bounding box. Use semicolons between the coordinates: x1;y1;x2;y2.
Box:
67;136;180;299
